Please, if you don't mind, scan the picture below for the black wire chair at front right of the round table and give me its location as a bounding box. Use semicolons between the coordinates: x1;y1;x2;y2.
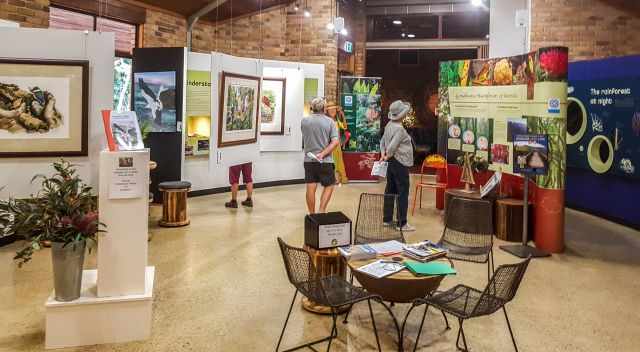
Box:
412;257;531;352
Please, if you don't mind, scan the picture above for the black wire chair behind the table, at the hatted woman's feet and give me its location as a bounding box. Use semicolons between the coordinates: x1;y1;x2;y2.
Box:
354;193;405;244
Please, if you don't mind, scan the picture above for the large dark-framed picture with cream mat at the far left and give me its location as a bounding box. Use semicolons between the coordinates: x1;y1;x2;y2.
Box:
0;58;89;157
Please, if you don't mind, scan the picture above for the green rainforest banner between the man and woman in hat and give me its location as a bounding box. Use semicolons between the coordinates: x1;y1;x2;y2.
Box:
340;77;382;153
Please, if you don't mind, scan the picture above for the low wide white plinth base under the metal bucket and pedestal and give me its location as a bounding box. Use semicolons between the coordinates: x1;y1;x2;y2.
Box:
45;266;155;349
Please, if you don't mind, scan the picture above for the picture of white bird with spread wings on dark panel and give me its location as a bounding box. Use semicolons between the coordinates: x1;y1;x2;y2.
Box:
133;71;178;132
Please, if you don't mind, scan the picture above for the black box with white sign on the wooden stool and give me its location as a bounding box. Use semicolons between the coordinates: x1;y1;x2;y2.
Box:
304;212;351;249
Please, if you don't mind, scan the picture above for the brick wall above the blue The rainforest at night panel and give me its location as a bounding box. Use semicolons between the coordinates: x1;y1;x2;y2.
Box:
531;0;640;61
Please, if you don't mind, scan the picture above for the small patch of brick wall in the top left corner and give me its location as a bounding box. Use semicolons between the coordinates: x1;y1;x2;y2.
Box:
0;0;49;28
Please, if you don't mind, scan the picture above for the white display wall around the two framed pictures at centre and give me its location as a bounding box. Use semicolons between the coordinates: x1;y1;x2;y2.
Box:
183;53;324;191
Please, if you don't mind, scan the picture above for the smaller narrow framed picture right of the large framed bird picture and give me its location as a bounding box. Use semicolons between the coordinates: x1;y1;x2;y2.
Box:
260;78;287;135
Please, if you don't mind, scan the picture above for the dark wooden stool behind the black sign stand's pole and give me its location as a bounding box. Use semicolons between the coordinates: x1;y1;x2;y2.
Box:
496;198;533;242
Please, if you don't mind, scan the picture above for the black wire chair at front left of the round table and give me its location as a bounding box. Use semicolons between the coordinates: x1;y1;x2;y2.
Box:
276;237;400;352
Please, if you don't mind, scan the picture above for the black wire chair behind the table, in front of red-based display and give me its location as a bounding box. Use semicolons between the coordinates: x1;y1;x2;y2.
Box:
439;197;495;280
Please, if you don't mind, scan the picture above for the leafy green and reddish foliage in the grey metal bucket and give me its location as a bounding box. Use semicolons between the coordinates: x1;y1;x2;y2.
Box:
0;160;104;266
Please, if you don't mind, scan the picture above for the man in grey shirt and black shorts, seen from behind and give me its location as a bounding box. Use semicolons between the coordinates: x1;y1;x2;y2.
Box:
301;98;340;214
